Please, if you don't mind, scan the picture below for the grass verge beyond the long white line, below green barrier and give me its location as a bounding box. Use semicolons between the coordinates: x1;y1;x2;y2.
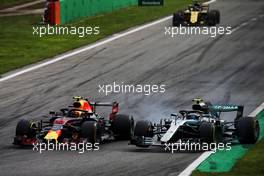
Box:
0;0;192;74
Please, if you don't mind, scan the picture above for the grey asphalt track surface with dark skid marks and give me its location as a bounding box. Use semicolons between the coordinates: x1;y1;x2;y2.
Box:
0;0;264;176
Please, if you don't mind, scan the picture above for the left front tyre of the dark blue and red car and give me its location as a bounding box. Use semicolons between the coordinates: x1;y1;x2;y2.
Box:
16;119;36;137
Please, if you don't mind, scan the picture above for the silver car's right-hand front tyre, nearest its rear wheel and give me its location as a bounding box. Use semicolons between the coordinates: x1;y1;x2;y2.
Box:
199;122;215;144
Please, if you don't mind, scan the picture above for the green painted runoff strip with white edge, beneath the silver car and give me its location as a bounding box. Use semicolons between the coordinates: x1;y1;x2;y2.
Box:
178;102;264;176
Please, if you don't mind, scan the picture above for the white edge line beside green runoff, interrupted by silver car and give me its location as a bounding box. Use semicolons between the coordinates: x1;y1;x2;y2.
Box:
178;102;264;176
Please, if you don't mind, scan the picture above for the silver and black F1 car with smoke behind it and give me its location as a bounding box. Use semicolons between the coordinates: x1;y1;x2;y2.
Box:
130;99;260;147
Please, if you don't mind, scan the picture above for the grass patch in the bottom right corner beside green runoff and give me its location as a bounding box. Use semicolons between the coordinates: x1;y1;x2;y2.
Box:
192;139;264;176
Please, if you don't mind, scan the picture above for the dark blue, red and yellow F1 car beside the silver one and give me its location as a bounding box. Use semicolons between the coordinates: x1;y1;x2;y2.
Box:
14;97;134;145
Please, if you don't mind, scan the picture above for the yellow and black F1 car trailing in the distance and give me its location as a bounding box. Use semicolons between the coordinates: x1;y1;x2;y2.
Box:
172;2;220;26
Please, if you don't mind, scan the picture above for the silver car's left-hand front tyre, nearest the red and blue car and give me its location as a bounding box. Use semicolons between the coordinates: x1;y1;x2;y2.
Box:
134;120;154;137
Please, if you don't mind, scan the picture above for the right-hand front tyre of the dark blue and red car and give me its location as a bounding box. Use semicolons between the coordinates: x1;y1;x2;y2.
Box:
81;121;101;144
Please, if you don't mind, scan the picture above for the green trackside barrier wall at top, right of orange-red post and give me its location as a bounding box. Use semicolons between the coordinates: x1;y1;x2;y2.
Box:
60;0;138;24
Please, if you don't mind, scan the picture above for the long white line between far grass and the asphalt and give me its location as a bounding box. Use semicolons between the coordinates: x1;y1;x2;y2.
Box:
0;0;216;82
